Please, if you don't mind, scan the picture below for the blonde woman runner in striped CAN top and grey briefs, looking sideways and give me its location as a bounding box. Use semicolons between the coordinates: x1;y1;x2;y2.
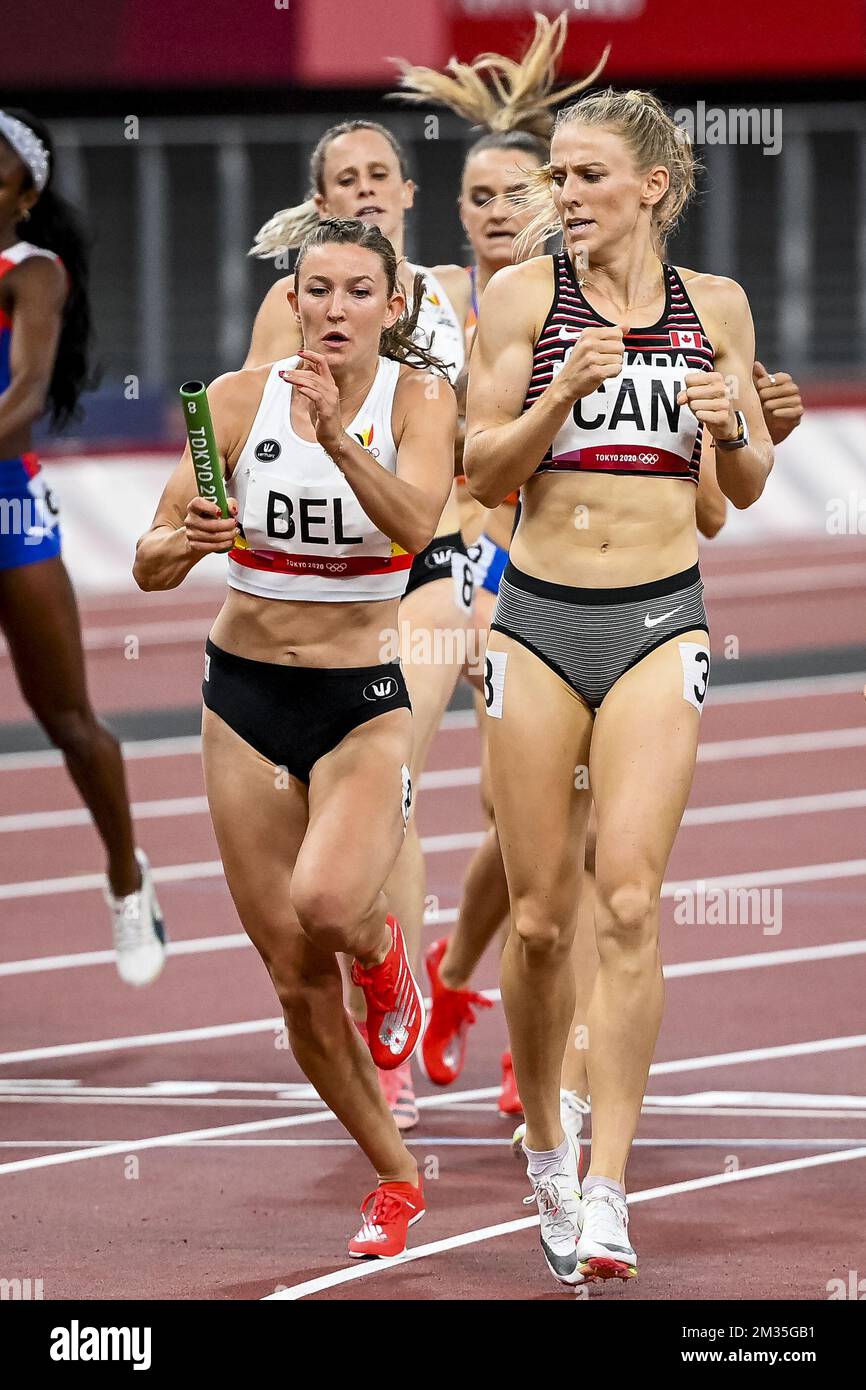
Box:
464;90;773;1283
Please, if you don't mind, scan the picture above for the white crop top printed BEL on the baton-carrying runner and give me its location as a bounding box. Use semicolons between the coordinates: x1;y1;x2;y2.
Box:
227;357;413;603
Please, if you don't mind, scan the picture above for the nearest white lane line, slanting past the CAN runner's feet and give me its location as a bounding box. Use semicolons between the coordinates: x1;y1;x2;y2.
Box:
264;1145;866;1302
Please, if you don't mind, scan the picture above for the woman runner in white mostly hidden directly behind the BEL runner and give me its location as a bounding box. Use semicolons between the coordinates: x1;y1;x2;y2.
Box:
246;121;474;1129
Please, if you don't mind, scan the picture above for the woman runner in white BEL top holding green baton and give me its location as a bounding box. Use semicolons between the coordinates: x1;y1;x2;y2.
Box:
135;220;457;1255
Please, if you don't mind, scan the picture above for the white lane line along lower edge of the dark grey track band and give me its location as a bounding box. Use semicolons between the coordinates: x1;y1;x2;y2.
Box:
0;671;866;773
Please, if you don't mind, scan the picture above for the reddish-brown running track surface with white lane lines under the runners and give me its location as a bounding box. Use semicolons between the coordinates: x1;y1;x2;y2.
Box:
0;541;866;1300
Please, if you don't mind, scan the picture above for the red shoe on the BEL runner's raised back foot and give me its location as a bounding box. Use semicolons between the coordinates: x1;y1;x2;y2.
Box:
352;916;424;1072
